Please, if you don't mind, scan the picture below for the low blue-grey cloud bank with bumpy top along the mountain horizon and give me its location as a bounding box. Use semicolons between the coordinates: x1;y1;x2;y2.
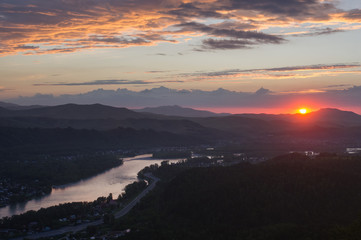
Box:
7;86;361;112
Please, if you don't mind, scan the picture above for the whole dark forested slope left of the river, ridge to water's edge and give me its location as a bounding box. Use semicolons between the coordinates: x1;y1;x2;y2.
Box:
0;127;201;206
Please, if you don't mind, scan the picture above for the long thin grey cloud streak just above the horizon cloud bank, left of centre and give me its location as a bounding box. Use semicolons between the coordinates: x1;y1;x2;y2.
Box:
34;80;183;86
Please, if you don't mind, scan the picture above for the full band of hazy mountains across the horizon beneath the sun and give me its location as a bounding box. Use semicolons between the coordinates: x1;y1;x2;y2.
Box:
0;104;361;153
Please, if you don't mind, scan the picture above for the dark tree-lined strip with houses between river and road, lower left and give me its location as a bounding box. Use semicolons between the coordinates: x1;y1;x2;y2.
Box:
0;179;150;239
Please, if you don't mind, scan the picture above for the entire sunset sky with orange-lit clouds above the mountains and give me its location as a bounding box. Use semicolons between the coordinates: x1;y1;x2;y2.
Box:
0;0;361;113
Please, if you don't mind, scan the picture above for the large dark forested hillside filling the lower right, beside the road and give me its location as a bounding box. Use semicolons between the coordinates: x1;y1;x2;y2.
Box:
114;154;361;240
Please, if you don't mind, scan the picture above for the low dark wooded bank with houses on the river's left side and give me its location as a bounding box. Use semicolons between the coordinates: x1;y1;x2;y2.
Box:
0;151;123;207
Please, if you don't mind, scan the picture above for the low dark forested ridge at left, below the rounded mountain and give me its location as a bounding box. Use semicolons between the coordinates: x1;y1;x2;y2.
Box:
0;127;204;157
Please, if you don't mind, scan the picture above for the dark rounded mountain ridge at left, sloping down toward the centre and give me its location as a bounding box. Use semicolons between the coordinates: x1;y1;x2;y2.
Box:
0;104;225;136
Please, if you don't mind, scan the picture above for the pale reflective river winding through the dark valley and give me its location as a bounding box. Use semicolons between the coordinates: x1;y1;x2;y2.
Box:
0;154;180;218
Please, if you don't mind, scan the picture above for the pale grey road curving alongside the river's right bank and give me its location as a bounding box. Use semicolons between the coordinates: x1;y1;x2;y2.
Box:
11;173;160;240
